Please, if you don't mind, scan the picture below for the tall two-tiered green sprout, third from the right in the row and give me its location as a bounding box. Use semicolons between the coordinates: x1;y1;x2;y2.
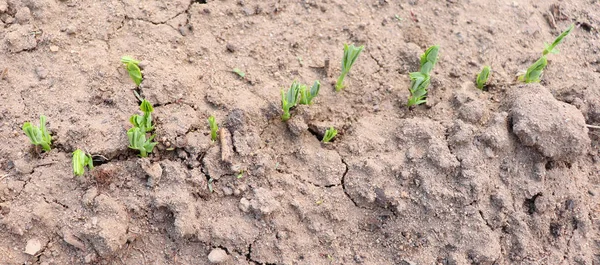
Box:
406;45;440;107
